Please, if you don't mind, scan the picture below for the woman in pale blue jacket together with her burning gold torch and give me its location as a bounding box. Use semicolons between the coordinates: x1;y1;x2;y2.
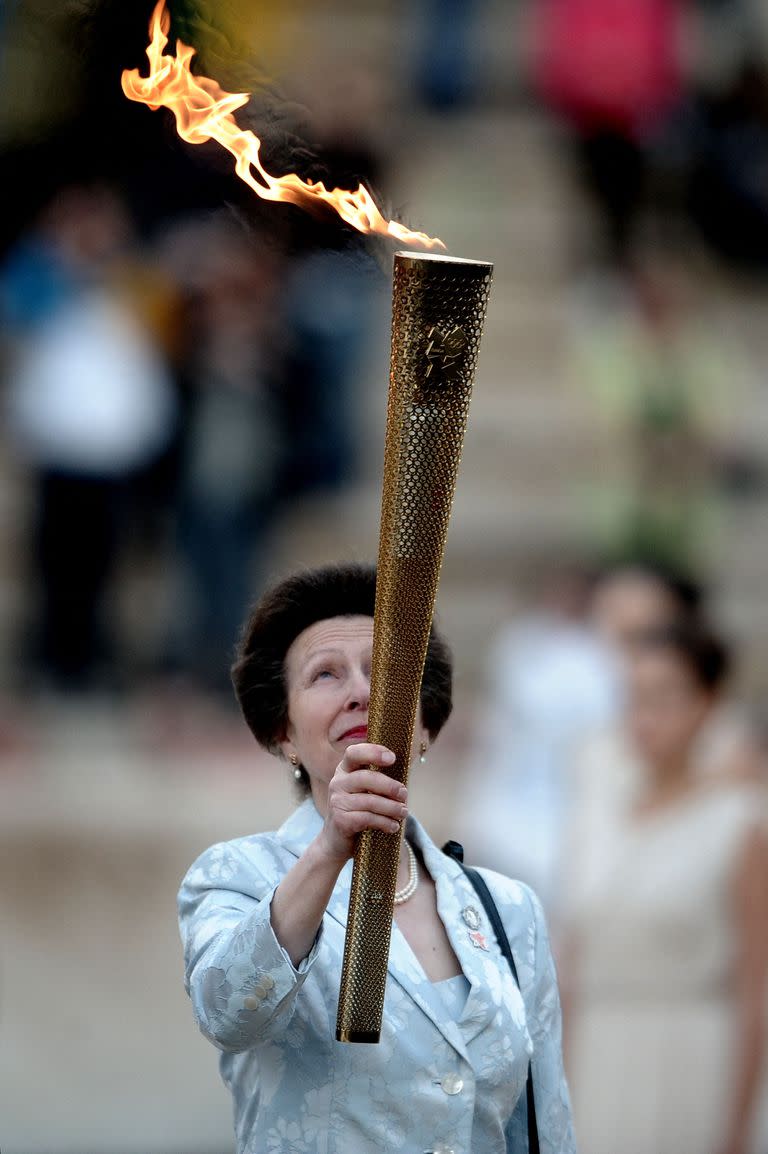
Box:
122;13;574;1154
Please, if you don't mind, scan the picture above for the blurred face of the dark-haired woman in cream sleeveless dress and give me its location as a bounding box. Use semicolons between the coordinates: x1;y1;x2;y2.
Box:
627;649;715;767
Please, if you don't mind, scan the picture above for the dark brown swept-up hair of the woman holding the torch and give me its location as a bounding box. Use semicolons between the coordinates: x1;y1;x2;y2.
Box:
232;562;453;780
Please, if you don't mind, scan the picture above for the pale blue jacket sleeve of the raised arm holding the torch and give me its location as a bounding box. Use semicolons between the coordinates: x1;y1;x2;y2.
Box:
178;842;323;1054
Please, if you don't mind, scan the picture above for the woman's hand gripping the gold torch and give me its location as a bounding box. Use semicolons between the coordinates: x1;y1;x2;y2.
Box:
318;742;408;864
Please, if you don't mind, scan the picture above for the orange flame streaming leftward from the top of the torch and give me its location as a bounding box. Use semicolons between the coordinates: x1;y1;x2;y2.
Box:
122;0;445;248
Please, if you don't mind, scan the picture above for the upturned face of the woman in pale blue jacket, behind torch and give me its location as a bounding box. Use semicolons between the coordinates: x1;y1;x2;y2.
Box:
280;616;424;811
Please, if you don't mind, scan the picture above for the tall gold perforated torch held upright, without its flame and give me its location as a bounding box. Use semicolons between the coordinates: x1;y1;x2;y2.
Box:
336;253;494;1042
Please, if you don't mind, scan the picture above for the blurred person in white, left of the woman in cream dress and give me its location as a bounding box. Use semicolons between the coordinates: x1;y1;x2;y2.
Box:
454;565;619;916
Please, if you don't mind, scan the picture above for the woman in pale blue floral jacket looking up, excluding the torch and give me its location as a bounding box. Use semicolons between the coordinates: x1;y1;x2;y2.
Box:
179;564;575;1154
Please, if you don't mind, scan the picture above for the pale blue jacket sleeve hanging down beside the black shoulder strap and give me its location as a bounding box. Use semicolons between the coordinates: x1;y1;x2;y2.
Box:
506;885;577;1154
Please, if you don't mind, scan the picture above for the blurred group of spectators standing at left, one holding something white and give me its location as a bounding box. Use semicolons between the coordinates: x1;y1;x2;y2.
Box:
0;183;378;692
